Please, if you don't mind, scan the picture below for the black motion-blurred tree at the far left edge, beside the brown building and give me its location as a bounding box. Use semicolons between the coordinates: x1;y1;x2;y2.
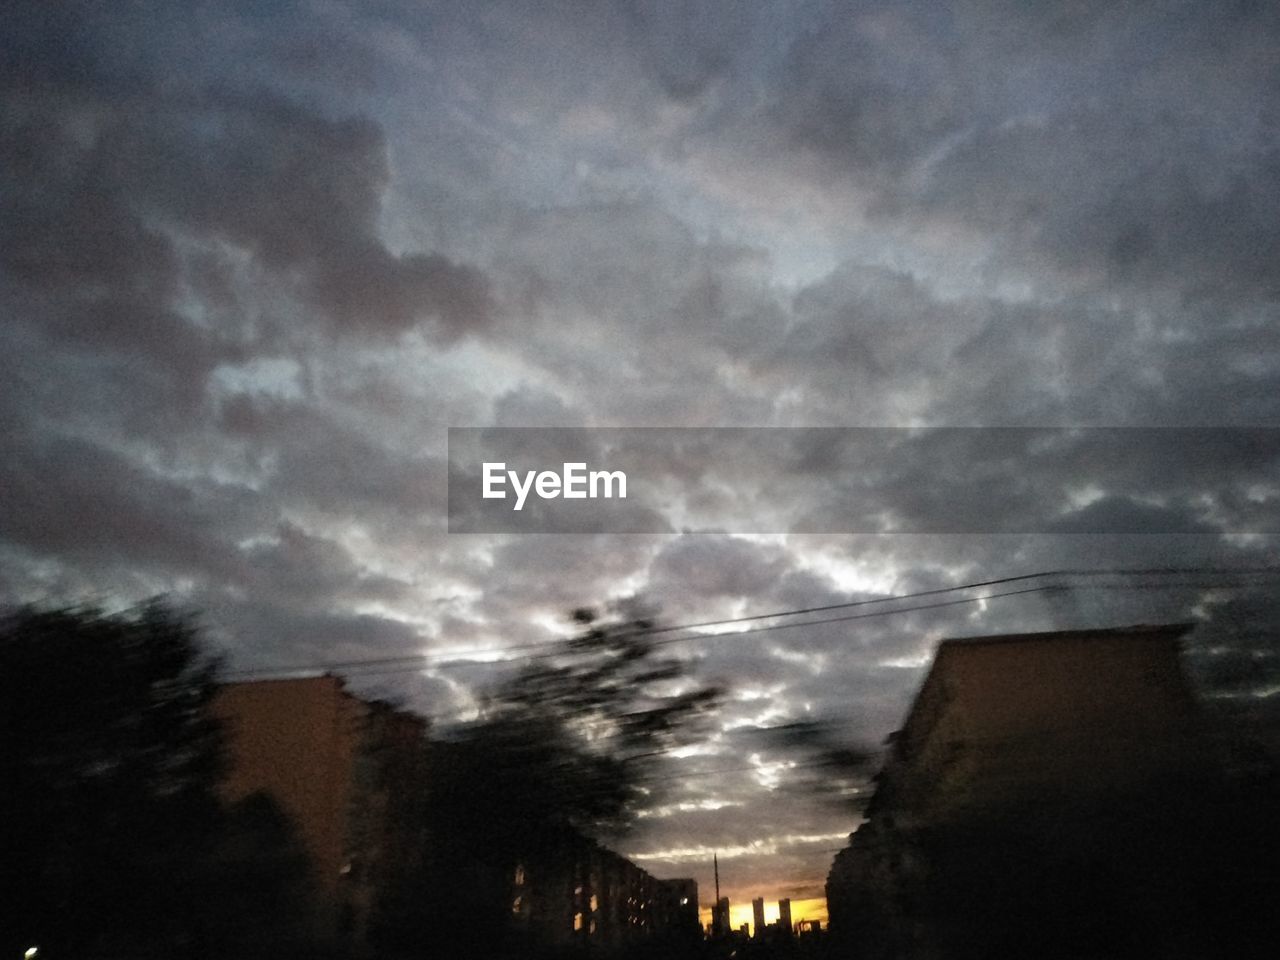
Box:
0;602;221;956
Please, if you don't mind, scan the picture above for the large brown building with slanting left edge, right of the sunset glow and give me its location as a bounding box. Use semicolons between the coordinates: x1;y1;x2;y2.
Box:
827;625;1274;960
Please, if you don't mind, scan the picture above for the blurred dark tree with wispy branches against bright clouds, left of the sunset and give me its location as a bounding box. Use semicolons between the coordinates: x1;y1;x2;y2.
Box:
373;609;721;956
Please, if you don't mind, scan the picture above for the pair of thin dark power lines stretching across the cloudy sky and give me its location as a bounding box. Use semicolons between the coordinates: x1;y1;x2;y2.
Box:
225;566;1280;680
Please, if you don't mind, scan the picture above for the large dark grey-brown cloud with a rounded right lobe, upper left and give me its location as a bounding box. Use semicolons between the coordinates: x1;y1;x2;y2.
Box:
4;5;494;355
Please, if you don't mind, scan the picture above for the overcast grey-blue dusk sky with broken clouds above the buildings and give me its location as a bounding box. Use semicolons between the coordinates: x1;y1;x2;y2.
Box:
0;0;1280;919
